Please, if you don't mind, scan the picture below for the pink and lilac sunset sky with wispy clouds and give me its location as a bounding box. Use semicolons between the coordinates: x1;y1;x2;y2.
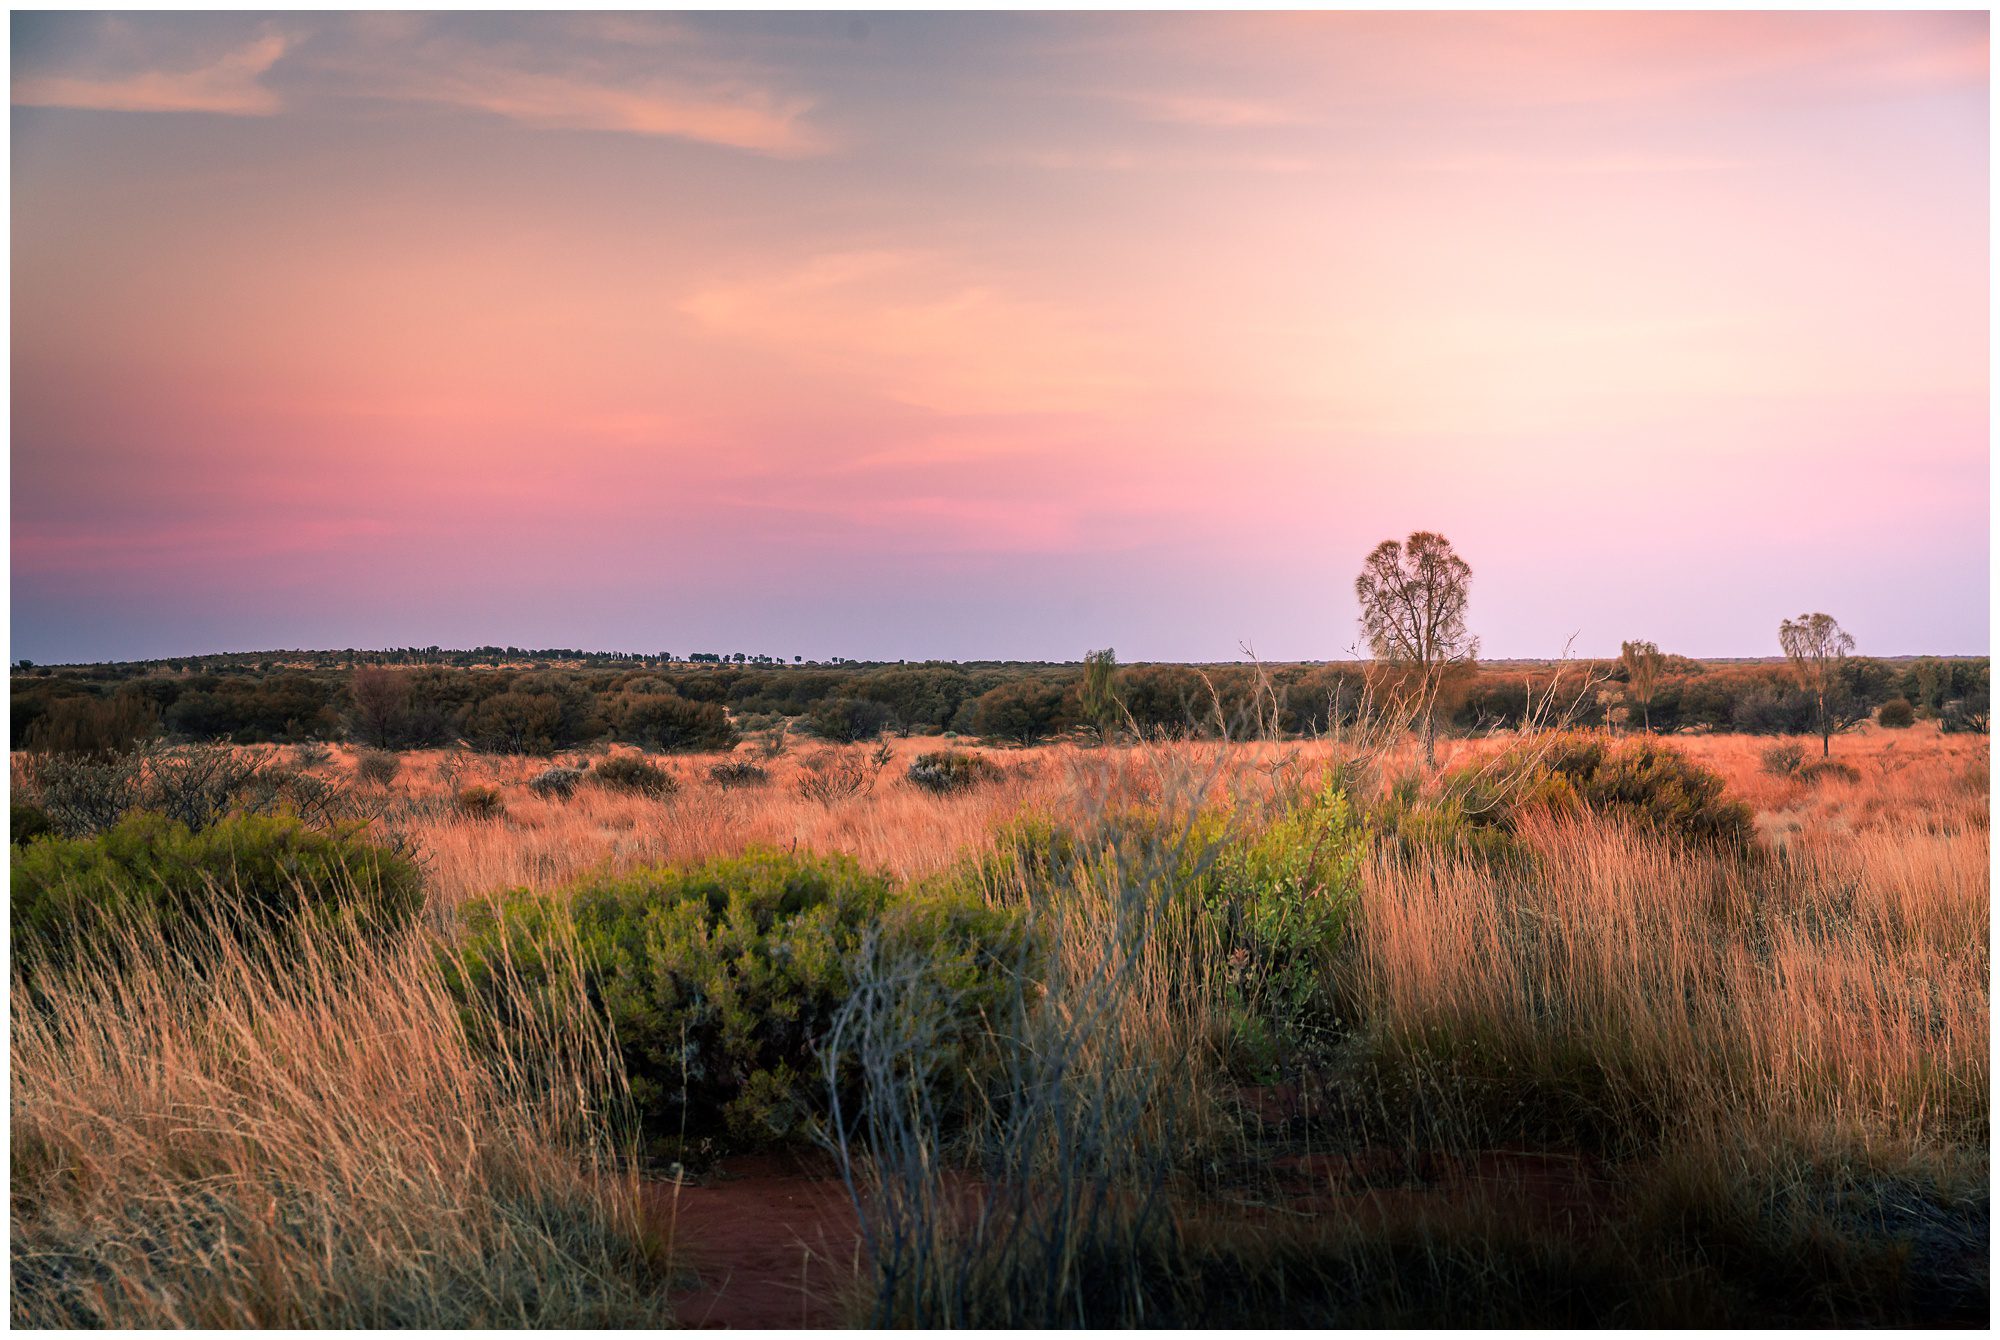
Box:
12;12;1990;662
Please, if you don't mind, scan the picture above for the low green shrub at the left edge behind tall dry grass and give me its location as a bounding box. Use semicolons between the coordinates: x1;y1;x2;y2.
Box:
10;814;422;968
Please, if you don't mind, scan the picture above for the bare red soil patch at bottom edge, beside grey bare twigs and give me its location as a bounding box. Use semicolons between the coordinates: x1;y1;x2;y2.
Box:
648;1156;860;1330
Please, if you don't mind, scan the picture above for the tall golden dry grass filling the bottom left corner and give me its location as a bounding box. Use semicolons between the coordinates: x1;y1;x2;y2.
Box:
10;908;670;1328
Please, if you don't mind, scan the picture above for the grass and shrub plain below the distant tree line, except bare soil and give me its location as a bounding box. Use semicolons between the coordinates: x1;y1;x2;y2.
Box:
12;712;1990;1326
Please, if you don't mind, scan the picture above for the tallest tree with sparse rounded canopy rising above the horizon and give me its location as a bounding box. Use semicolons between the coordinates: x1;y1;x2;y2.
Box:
1354;530;1480;766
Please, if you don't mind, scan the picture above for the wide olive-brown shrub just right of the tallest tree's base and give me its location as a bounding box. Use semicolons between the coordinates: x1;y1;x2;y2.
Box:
1442;734;1756;850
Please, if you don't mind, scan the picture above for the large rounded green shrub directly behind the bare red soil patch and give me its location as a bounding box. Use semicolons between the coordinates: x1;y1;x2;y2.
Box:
448;850;1022;1156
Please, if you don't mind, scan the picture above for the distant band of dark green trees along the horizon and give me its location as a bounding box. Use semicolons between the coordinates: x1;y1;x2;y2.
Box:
12;644;1988;754
